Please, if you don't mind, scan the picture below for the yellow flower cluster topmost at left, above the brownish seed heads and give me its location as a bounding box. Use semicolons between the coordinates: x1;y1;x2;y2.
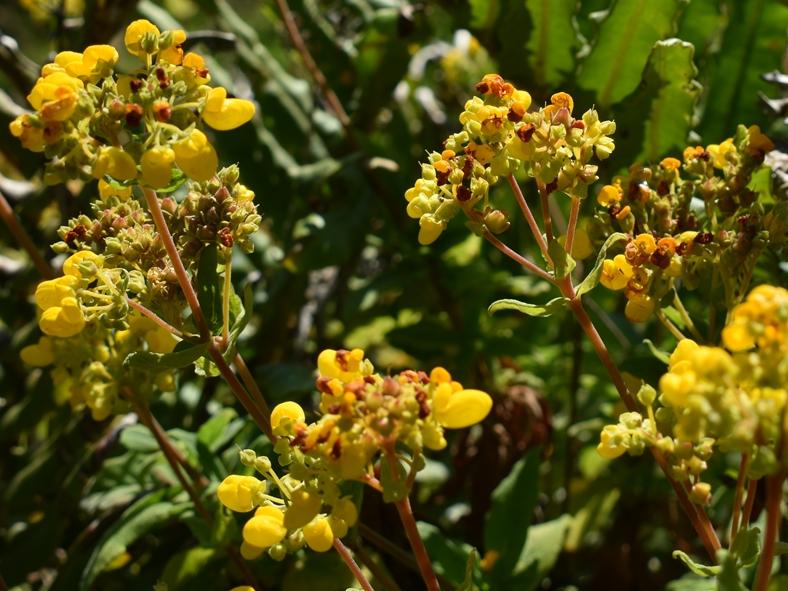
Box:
10;20;255;189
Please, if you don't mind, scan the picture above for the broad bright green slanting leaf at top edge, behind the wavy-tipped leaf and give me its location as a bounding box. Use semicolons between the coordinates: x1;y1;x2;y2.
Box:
578;0;687;106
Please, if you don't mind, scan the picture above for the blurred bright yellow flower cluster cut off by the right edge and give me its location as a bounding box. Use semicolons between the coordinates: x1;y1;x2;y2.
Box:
598;285;788;502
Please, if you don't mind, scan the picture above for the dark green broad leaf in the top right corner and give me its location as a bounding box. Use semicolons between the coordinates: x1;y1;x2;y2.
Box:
698;0;787;144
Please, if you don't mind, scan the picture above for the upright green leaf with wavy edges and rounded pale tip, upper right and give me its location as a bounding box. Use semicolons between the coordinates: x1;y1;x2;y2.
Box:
640;39;701;162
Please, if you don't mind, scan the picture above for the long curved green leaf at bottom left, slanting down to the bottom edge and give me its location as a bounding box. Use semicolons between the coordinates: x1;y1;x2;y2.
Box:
80;489;191;591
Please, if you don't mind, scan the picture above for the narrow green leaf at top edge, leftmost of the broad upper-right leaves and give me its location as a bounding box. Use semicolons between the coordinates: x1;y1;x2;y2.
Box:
525;0;585;86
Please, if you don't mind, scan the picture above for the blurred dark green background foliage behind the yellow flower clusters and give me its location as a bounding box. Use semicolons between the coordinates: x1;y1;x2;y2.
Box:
0;0;788;591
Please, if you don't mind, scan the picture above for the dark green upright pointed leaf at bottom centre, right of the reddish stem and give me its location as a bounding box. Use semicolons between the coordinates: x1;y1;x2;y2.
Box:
484;448;541;580
